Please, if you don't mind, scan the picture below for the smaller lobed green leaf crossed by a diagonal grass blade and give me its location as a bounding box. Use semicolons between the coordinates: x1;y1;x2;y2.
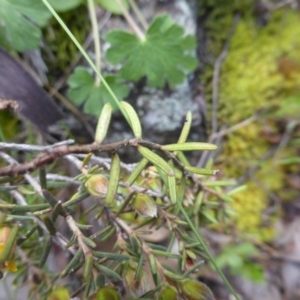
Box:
68;67;129;116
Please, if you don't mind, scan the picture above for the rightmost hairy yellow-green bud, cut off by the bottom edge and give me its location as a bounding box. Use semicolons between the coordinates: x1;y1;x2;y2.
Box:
180;279;215;300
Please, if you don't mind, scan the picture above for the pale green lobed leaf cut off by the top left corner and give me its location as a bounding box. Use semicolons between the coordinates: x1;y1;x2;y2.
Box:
0;0;51;52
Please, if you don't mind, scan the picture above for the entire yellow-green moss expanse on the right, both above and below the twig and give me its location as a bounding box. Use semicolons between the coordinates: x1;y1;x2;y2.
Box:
203;10;300;240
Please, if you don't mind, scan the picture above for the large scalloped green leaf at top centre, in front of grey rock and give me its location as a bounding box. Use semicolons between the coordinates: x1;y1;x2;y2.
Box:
106;15;197;87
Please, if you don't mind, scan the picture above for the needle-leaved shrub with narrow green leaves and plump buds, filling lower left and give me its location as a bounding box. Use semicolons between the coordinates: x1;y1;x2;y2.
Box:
0;104;237;300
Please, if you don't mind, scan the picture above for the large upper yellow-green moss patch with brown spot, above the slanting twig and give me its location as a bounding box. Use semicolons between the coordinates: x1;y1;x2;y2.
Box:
219;11;300;124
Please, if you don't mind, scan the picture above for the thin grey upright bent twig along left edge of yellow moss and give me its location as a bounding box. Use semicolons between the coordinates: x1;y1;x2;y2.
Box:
212;14;240;134
